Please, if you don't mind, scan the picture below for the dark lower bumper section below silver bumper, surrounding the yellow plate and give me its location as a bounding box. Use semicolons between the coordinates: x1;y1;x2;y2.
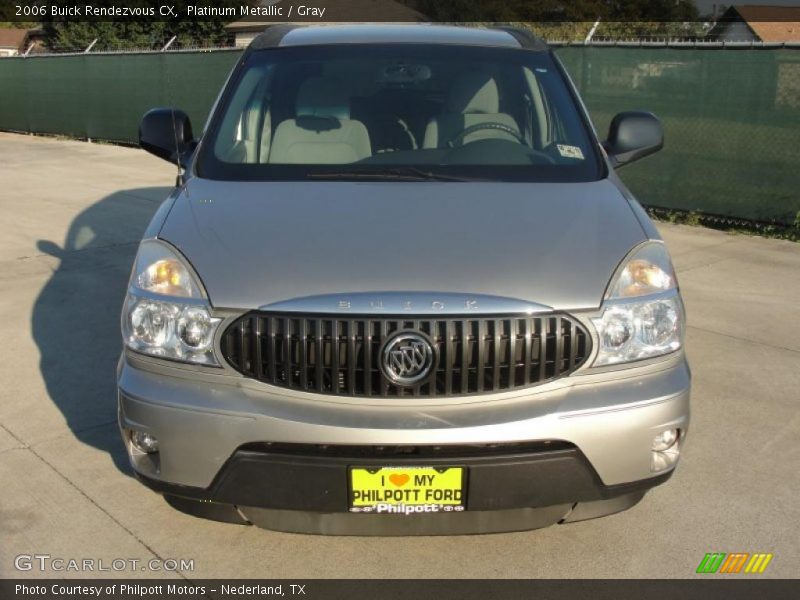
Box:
138;442;673;535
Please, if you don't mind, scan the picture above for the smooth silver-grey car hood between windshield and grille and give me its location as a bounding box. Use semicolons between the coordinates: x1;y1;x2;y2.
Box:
159;178;645;309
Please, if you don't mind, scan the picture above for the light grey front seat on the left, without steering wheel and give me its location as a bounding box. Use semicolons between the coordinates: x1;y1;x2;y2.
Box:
269;77;372;164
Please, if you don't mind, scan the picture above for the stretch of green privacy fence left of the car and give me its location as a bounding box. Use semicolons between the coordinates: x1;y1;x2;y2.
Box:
0;50;239;142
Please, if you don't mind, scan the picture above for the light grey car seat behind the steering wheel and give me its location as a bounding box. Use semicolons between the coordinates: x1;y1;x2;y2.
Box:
423;71;519;148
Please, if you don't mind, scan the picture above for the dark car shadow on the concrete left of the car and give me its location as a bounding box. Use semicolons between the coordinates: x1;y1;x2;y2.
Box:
32;187;170;473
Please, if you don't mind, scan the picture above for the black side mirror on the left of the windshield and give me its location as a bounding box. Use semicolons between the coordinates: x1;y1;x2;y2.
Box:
139;108;197;169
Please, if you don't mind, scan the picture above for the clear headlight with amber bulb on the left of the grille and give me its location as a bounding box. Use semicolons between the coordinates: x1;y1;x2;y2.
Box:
122;240;221;365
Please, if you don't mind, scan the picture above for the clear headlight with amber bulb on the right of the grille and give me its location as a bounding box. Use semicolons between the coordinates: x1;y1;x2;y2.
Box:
593;242;684;366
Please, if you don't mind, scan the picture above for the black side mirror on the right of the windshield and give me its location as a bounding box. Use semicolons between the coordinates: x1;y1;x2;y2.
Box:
603;111;664;167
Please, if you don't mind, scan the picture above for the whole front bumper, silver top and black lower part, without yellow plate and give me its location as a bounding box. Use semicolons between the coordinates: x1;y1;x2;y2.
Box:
118;354;690;529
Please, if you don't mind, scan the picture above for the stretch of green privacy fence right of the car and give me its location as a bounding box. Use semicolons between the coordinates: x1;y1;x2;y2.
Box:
559;47;800;224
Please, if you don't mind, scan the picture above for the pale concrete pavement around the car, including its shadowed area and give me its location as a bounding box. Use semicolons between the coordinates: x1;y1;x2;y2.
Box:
0;133;800;578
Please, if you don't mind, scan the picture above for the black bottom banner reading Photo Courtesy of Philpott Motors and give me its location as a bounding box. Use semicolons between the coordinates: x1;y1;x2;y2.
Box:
0;575;800;600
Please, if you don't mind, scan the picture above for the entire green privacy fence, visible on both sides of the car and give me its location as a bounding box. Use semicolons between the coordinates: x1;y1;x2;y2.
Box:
0;46;800;224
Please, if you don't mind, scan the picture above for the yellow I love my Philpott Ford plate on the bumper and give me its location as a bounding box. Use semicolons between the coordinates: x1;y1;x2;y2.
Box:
350;467;466;515
